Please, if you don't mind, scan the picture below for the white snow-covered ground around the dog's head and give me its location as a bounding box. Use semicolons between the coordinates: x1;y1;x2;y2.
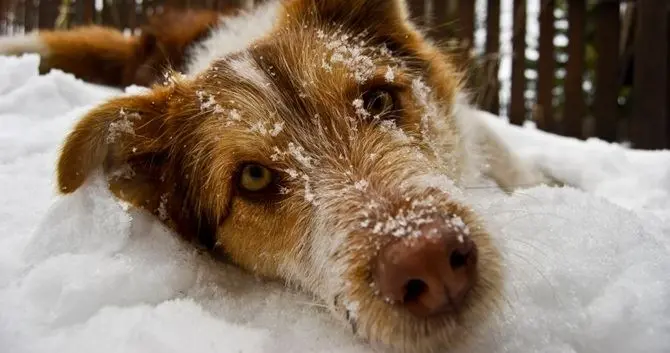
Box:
0;56;670;353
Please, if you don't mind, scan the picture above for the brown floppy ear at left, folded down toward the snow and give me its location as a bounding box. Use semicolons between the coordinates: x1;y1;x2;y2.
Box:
57;83;171;201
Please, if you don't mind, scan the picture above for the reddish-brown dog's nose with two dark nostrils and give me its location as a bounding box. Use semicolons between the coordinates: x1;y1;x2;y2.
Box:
373;228;477;317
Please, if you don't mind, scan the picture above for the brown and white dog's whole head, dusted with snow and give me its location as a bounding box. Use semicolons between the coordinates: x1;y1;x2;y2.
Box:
59;0;502;351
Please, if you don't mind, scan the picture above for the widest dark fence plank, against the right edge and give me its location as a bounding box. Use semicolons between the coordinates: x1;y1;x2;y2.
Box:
632;0;668;149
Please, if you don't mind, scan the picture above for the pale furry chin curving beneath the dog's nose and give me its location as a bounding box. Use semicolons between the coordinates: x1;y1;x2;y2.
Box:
329;230;503;353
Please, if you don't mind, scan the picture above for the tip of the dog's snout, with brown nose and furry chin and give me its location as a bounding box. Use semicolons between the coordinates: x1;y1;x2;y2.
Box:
316;197;502;352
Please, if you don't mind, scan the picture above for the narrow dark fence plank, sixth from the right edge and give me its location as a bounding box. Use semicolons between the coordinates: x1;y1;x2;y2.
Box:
480;0;500;115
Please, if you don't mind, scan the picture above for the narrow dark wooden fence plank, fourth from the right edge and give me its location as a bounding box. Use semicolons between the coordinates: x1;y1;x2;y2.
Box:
534;0;557;132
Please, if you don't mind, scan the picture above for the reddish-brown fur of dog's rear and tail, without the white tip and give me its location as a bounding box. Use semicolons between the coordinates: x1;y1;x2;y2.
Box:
39;6;228;87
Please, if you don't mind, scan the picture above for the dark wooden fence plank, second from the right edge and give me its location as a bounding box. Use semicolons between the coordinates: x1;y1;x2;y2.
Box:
593;1;621;142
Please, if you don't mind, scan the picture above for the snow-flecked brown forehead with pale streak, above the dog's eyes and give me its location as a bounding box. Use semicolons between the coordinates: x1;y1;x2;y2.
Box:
192;28;406;131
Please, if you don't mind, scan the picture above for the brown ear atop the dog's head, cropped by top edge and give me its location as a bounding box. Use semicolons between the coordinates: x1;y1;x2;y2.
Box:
286;0;409;28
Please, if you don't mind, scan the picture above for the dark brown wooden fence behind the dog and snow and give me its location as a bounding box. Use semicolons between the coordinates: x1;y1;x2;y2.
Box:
0;0;670;149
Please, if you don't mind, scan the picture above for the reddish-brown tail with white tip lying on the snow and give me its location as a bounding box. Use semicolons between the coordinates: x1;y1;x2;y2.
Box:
0;26;137;87
